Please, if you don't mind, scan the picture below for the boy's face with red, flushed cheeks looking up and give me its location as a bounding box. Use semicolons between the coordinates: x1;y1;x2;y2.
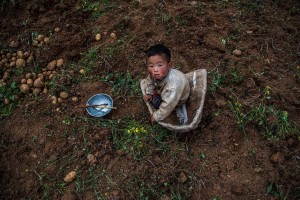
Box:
147;55;170;80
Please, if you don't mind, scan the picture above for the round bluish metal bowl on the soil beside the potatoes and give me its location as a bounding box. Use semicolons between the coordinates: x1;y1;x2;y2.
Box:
86;94;113;117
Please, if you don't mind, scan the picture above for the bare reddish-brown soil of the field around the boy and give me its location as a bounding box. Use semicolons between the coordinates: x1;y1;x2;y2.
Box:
0;0;300;200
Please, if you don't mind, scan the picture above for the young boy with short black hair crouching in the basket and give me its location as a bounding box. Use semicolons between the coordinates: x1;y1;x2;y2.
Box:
144;44;190;124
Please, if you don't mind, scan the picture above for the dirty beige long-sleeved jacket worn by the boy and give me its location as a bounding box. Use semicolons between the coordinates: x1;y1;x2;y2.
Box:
146;69;190;121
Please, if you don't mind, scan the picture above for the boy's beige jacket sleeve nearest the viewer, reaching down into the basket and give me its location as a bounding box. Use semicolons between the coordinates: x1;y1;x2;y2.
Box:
153;87;183;121
